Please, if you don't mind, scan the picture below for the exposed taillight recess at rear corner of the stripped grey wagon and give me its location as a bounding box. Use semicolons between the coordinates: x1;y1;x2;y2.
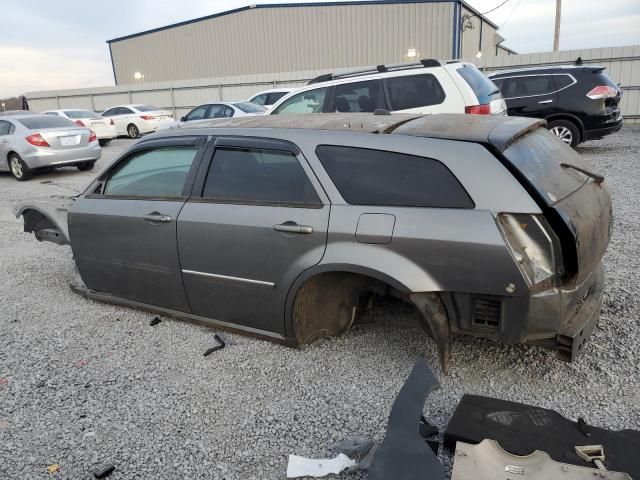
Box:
498;213;560;288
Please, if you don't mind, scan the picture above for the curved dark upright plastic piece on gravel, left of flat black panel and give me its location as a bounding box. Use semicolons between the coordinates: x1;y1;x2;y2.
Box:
367;359;444;480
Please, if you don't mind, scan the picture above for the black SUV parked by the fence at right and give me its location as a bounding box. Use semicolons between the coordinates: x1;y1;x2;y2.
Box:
489;65;622;147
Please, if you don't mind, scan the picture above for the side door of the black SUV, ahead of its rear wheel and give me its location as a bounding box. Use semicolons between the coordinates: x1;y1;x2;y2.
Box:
494;74;558;118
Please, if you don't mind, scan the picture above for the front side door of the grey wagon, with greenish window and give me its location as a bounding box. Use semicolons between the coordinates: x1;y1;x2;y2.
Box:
69;137;204;312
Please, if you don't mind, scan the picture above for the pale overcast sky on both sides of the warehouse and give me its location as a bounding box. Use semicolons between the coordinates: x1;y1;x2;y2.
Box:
0;0;640;98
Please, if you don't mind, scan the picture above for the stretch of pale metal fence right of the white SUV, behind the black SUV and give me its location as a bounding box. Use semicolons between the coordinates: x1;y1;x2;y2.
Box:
469;45;640;123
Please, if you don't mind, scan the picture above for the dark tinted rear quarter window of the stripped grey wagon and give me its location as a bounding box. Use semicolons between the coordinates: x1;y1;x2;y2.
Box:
316;145;475;208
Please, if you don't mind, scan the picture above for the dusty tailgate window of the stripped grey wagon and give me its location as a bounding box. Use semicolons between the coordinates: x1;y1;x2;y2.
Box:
504;128;597;205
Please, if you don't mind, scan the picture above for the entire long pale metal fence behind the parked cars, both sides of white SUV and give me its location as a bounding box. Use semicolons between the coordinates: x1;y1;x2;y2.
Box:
27;46;640;122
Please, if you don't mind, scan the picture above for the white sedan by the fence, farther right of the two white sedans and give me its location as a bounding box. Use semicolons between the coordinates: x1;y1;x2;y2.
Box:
102;104;173;138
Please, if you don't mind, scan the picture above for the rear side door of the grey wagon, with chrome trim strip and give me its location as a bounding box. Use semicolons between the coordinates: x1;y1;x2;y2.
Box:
178;137;330;334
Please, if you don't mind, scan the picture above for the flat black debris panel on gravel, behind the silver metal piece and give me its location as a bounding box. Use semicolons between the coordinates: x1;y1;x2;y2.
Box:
444;395;640;479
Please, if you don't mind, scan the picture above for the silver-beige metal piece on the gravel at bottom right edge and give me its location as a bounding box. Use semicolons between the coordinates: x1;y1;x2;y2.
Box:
451;439;631;480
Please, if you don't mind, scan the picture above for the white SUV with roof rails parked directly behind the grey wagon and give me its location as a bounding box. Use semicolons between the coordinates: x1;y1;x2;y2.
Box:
268;60;507;115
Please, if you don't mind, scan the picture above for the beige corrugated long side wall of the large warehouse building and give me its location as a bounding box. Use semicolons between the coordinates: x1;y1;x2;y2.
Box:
110;1;454;84
